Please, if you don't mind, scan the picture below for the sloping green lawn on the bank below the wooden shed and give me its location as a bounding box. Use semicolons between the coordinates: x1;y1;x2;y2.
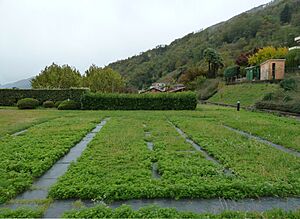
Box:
208;84;279;107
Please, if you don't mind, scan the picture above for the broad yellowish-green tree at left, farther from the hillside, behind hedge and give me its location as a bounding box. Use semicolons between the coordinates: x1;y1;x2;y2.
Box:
31;63;82;89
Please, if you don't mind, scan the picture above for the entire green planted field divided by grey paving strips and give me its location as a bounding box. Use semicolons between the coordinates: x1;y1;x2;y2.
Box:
0;105;300;217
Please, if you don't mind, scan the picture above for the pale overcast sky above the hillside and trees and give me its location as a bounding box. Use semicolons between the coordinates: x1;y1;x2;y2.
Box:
0;0;270;84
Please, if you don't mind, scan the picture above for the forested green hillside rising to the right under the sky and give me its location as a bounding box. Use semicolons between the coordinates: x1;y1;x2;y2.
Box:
109;0;300;88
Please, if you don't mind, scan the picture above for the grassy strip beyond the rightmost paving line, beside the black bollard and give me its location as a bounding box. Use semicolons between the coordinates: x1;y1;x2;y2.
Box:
202;106;300;151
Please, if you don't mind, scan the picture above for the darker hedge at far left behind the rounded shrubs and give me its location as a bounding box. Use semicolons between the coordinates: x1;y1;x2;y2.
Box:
0;88;88;106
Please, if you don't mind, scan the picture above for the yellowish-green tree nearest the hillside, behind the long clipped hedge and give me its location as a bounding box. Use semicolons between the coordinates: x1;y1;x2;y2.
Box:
83;65;124;93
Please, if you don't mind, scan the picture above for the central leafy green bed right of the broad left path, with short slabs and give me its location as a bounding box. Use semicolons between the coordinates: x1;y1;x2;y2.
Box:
49;114;227;200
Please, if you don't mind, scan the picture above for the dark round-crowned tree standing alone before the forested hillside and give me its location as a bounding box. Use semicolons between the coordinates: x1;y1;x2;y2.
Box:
204;48;224;78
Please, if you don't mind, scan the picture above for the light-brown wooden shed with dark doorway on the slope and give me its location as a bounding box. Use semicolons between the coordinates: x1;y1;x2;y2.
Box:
260;59;285;81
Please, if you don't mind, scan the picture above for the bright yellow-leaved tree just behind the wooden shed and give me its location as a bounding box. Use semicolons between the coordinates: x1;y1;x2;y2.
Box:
248;46;289;65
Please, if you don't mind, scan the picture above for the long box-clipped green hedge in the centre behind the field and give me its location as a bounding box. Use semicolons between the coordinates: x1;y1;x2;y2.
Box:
81;92;197;110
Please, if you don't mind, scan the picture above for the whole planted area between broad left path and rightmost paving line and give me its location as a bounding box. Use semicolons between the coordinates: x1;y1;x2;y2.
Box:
50;112;300;200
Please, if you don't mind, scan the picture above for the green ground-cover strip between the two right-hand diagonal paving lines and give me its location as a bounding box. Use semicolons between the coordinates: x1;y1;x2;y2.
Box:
170;117;300;197
